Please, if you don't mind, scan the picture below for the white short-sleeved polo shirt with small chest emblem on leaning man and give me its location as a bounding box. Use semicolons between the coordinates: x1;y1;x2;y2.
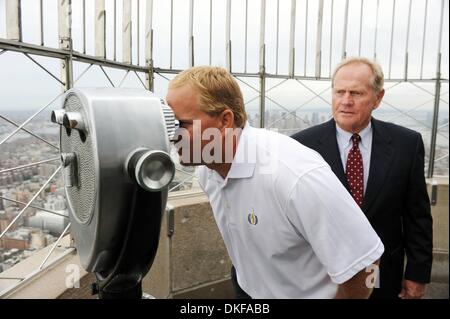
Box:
197;123;384;298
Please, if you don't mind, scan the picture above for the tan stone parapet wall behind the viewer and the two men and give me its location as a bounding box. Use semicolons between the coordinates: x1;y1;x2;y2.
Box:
0;178;449;299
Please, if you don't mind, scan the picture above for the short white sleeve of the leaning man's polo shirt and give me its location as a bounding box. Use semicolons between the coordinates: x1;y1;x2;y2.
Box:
286;167;384;284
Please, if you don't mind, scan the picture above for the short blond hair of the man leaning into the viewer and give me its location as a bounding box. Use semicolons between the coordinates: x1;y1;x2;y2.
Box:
169;66;247;127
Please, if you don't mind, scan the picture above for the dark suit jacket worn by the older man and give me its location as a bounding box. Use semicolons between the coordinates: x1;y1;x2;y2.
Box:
292;118;433;298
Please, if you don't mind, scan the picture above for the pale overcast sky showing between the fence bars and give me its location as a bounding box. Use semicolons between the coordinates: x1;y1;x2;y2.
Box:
0;0;449;114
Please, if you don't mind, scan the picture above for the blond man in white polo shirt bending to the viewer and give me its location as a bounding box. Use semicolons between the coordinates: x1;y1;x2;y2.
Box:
167;67;384;298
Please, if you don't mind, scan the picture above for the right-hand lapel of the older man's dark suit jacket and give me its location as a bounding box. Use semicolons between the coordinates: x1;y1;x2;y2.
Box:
362;119;394;215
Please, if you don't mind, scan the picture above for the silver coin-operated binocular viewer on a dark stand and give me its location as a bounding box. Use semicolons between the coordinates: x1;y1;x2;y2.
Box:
51;88;176;298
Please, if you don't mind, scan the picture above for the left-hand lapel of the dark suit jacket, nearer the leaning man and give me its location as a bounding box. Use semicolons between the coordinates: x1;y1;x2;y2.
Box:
319;119;349;189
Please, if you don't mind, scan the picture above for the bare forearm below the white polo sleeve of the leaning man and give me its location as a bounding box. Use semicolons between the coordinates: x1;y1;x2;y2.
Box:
334;260;379;299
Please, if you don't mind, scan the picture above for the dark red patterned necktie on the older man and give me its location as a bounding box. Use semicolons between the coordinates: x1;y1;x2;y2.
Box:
346;134;364;207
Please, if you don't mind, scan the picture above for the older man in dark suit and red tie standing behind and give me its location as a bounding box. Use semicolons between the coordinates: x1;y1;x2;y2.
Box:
292;58;432;298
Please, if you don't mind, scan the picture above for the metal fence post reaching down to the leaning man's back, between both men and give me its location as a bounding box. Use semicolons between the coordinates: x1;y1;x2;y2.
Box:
259;0;266;127
